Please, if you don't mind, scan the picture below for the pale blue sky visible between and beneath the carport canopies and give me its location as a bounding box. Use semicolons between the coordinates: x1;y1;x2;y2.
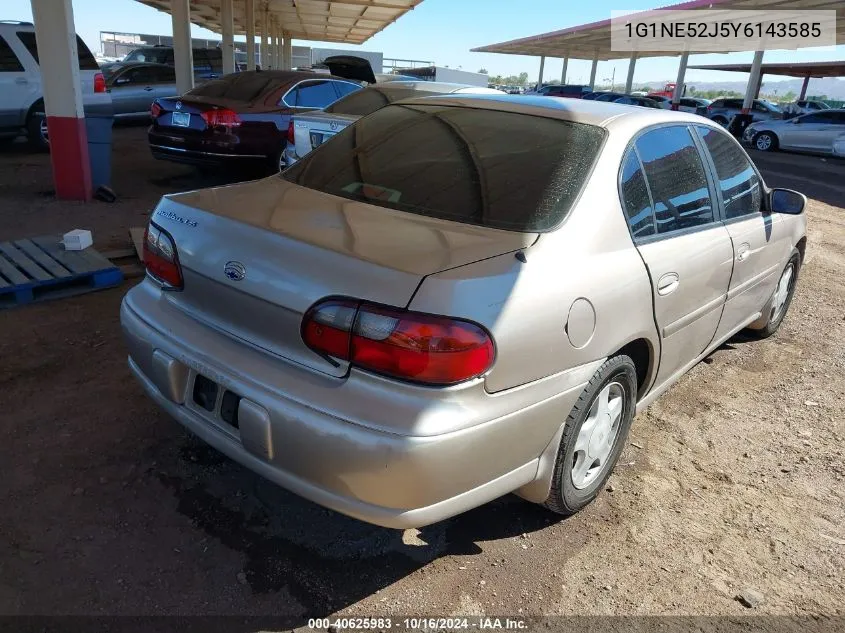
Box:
0;0;845;83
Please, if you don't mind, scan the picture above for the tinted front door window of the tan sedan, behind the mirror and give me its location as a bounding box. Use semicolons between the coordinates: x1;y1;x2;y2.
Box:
697;127;763;220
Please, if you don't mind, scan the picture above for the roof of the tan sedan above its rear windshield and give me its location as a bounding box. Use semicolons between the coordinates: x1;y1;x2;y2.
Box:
397;94;704;129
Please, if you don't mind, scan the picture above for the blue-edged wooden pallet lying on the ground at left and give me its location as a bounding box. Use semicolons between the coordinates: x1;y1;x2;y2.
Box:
0;235;123;309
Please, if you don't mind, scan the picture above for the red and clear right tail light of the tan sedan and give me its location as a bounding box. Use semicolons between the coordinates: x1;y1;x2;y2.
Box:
302;299;495;386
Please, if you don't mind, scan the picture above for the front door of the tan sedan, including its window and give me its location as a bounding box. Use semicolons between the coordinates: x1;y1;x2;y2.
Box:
696;126;792;338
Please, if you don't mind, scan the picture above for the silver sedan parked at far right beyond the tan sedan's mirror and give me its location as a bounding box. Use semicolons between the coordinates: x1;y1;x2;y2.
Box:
743;109;845;154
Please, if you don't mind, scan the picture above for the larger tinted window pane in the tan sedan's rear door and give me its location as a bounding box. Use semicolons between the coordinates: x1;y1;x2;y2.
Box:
636;126;714;234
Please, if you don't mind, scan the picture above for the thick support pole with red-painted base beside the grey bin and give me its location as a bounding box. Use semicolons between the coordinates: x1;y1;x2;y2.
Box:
30;0;90;200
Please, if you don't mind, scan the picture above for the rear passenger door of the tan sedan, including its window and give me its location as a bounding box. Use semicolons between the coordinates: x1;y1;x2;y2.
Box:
622;125;733;385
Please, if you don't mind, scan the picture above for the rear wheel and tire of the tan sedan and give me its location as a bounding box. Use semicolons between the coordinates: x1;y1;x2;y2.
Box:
543;356;637;516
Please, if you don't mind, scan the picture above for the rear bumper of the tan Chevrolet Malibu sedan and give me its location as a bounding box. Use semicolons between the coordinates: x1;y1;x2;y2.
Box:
121;281;587;529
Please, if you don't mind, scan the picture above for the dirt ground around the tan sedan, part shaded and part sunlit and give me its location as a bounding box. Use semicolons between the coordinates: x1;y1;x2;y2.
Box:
0;127;845;618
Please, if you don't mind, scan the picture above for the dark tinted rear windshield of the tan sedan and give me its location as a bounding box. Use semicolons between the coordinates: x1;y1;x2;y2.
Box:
283;103;604;232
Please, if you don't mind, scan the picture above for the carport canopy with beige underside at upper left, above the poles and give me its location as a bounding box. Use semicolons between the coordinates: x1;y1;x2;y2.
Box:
137;0;422;44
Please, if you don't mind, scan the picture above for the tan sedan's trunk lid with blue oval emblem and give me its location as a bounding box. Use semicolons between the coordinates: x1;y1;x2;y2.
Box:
152;176;537;376
